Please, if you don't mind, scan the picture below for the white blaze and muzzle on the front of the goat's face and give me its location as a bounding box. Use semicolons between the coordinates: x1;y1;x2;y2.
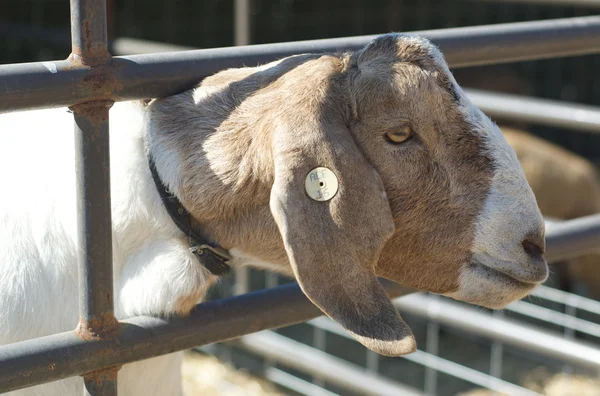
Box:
449;89;548;307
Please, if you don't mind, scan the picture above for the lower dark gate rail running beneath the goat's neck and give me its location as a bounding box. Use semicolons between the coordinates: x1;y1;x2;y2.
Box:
0;280;412;392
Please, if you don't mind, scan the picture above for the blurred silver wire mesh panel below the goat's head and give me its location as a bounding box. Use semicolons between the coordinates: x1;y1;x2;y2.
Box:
204;264;600;395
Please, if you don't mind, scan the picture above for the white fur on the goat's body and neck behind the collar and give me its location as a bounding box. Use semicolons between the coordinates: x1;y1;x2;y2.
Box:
0;103;214;396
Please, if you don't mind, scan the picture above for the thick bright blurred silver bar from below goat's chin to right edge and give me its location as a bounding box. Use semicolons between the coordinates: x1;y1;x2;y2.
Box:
394;293;600;370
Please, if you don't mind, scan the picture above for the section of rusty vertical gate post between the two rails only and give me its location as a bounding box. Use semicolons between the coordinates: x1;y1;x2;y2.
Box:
72;101;115;336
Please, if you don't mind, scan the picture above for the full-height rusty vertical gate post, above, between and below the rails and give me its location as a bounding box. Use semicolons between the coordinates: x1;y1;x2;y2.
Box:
69;0;119;396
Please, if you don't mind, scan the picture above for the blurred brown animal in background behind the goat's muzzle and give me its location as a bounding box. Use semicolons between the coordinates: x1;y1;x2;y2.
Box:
501;126;600;299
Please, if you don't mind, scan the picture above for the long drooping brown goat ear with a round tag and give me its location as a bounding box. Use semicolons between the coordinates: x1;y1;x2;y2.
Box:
270;116;416;356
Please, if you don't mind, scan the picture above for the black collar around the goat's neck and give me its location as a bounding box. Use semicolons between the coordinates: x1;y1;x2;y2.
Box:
148;155;231;276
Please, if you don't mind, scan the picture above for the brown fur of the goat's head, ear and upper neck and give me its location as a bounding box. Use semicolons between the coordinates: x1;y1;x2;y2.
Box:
150;35;500;355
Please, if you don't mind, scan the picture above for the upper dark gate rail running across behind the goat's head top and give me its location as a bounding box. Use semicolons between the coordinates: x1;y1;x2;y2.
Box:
0;16;600;112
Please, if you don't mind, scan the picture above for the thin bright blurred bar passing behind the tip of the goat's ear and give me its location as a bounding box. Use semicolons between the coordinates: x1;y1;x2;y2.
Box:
310;318;538;396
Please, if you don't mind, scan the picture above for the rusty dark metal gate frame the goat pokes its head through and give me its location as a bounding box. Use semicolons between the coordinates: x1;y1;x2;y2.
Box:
0;0;600;396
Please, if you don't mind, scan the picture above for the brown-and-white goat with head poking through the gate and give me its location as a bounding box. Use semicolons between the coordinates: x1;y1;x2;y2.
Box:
0;34;548;395
